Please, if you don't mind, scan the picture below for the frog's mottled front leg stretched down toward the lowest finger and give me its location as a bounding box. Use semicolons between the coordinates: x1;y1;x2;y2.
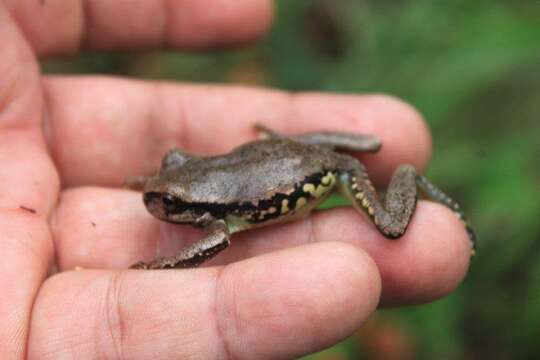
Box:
131;220;230;269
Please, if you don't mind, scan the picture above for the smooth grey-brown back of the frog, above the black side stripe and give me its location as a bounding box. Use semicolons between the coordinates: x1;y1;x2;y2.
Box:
181;139;335;204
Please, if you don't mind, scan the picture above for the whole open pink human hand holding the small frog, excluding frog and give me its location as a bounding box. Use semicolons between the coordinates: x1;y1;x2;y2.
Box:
0;0;470;359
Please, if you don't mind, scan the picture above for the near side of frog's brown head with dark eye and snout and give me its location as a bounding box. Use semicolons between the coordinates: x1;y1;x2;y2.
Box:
143;176;205;224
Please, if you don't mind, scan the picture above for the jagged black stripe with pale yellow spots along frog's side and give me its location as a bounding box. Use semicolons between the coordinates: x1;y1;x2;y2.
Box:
153;171;333;223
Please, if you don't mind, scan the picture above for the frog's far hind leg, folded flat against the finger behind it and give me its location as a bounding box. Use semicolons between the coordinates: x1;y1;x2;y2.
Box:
255;123;381;152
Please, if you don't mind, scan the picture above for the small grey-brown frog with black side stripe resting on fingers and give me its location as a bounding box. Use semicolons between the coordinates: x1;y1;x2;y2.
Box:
127;123;476;269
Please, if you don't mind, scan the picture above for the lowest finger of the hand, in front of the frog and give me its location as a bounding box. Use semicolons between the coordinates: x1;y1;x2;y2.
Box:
29;243;380;359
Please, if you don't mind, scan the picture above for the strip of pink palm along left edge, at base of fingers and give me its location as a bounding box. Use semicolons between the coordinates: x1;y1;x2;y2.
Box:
0;4;58;358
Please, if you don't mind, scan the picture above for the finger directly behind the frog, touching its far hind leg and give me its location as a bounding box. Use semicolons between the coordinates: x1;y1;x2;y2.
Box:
45;77;431;186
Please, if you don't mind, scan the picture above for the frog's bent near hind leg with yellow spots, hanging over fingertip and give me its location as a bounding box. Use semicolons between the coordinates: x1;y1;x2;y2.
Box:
340;155;474;253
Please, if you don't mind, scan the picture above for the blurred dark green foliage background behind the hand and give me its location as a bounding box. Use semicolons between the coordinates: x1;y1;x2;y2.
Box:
44;0;540;360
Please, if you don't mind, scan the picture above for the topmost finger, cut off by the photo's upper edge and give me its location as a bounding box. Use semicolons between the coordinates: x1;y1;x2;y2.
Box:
6;0;272;55
